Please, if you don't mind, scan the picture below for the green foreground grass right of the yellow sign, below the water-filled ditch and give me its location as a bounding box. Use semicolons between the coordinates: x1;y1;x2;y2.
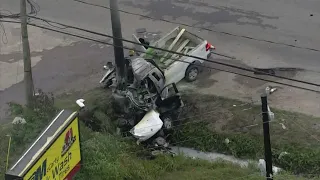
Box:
75;125;303;180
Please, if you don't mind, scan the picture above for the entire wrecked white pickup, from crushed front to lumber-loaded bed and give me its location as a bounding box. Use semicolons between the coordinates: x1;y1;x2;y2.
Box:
100;27;214;150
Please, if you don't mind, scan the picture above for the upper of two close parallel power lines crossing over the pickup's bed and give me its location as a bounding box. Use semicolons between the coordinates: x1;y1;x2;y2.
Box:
23;16;320;87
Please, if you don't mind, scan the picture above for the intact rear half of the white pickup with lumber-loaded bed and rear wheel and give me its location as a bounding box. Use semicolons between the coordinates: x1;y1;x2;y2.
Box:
133;27;215;85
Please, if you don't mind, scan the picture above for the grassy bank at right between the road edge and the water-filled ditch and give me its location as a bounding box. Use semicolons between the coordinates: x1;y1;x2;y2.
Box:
175;94;320;174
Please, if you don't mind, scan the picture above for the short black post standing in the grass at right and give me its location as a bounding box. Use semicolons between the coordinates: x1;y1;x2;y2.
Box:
261;94;273;180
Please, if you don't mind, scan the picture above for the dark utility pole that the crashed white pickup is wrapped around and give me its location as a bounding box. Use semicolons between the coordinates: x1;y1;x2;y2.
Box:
110;0;127;90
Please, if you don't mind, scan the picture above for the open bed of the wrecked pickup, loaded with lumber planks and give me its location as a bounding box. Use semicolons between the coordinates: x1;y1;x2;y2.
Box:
143;27;203;69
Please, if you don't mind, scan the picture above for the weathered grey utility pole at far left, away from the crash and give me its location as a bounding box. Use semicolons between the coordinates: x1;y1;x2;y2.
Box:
20;0;34;106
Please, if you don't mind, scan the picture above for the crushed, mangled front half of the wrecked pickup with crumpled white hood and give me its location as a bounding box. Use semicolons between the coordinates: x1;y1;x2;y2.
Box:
100;57;183;147
